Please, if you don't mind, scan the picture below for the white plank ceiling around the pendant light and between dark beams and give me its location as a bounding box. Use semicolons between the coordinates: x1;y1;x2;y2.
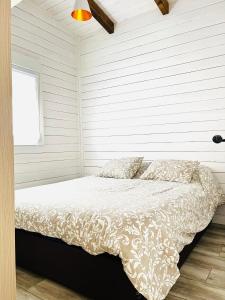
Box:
32;0;164;35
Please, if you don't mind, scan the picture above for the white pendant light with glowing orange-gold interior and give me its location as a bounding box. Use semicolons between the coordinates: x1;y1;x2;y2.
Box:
71;0;92;21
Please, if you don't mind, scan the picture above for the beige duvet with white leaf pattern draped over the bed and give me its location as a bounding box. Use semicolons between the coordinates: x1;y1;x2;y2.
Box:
16;167;222;300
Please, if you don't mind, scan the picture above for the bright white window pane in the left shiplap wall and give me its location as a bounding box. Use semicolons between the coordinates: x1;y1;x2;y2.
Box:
12;66;41;145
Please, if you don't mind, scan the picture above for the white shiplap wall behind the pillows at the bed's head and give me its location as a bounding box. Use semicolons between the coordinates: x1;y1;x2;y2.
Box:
81;0;225;222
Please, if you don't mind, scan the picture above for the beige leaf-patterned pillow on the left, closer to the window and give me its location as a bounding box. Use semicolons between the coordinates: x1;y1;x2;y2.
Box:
97;157;143;179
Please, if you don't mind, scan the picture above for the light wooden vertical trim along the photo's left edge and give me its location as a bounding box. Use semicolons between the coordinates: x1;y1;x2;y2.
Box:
0;0;16;300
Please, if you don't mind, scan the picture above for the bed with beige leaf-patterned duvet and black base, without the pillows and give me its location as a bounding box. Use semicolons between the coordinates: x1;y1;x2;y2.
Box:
16;167;221;300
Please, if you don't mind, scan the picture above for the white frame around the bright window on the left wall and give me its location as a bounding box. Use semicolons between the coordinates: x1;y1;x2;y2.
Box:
12;63;44;147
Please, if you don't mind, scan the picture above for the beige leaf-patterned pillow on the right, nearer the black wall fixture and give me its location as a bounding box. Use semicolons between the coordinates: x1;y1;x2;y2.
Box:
141;160;199;183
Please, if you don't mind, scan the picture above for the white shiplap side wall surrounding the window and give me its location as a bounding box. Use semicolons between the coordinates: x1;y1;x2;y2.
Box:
12;0;80;188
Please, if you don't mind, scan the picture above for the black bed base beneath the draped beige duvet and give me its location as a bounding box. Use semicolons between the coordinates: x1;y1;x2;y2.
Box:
16;229;207;300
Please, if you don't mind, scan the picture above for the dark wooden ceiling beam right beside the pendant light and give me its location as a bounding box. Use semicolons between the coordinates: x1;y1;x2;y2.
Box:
88;0;115;34
